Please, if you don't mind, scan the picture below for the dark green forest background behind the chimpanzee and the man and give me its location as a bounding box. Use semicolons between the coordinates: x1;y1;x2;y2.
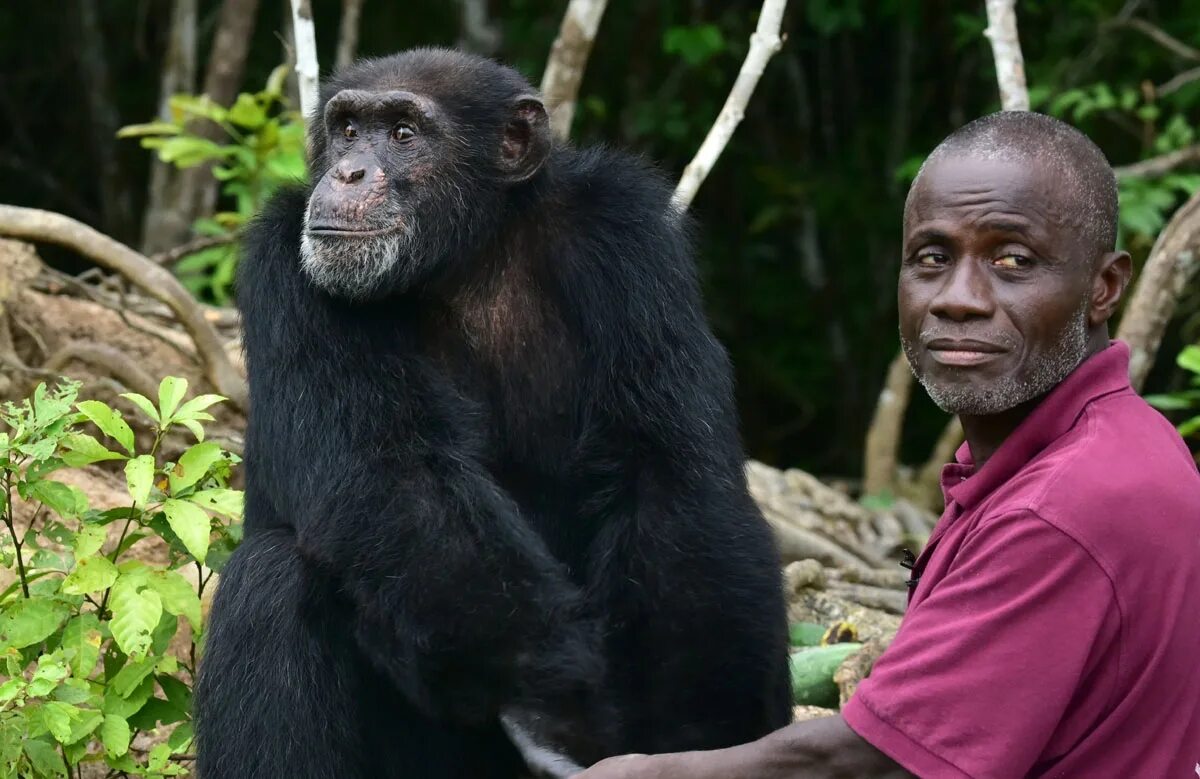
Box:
0;0;1200;491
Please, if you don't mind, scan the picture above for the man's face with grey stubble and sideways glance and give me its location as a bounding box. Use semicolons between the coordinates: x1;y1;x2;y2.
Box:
899;152;1093;415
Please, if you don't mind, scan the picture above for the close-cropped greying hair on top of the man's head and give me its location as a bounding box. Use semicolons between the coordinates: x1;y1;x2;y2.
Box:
905;110;1117;256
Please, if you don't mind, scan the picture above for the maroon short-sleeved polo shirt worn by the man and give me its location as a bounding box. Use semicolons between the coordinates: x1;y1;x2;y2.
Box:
842;342;1200;779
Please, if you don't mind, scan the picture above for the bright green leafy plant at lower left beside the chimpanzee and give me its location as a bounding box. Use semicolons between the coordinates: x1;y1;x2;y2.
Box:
0;378;242;779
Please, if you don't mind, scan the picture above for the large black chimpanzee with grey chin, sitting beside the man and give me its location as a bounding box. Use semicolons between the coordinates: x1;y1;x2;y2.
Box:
197;49;791;779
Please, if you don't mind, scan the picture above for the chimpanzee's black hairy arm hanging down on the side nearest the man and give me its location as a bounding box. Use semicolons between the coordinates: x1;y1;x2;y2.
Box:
560;157;791;751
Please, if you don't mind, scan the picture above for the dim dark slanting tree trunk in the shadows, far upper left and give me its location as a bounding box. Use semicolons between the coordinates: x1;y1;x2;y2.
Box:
71;0;134;240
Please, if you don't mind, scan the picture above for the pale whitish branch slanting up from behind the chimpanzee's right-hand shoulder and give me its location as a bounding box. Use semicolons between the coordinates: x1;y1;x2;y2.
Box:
673;0;787;211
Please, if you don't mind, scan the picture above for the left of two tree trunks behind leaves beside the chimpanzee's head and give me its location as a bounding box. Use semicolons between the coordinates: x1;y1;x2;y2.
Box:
142;0;197;254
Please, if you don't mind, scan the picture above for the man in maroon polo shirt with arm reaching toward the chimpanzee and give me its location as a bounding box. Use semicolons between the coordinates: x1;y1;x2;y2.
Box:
581;112;1200;779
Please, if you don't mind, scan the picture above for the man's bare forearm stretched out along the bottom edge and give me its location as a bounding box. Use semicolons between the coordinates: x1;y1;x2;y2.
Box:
576;715;912;779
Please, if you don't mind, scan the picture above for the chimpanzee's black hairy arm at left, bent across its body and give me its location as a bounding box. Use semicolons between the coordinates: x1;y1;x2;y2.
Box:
239;192;602;721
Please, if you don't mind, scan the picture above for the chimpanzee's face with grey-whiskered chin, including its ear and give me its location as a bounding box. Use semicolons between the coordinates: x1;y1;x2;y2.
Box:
301;89;550;299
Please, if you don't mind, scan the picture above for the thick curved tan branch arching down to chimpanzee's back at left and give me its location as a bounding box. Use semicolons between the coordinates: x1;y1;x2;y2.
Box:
0;205;248;409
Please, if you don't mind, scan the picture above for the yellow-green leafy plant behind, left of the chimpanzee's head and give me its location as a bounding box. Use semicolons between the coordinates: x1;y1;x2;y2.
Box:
116;66;305;304
